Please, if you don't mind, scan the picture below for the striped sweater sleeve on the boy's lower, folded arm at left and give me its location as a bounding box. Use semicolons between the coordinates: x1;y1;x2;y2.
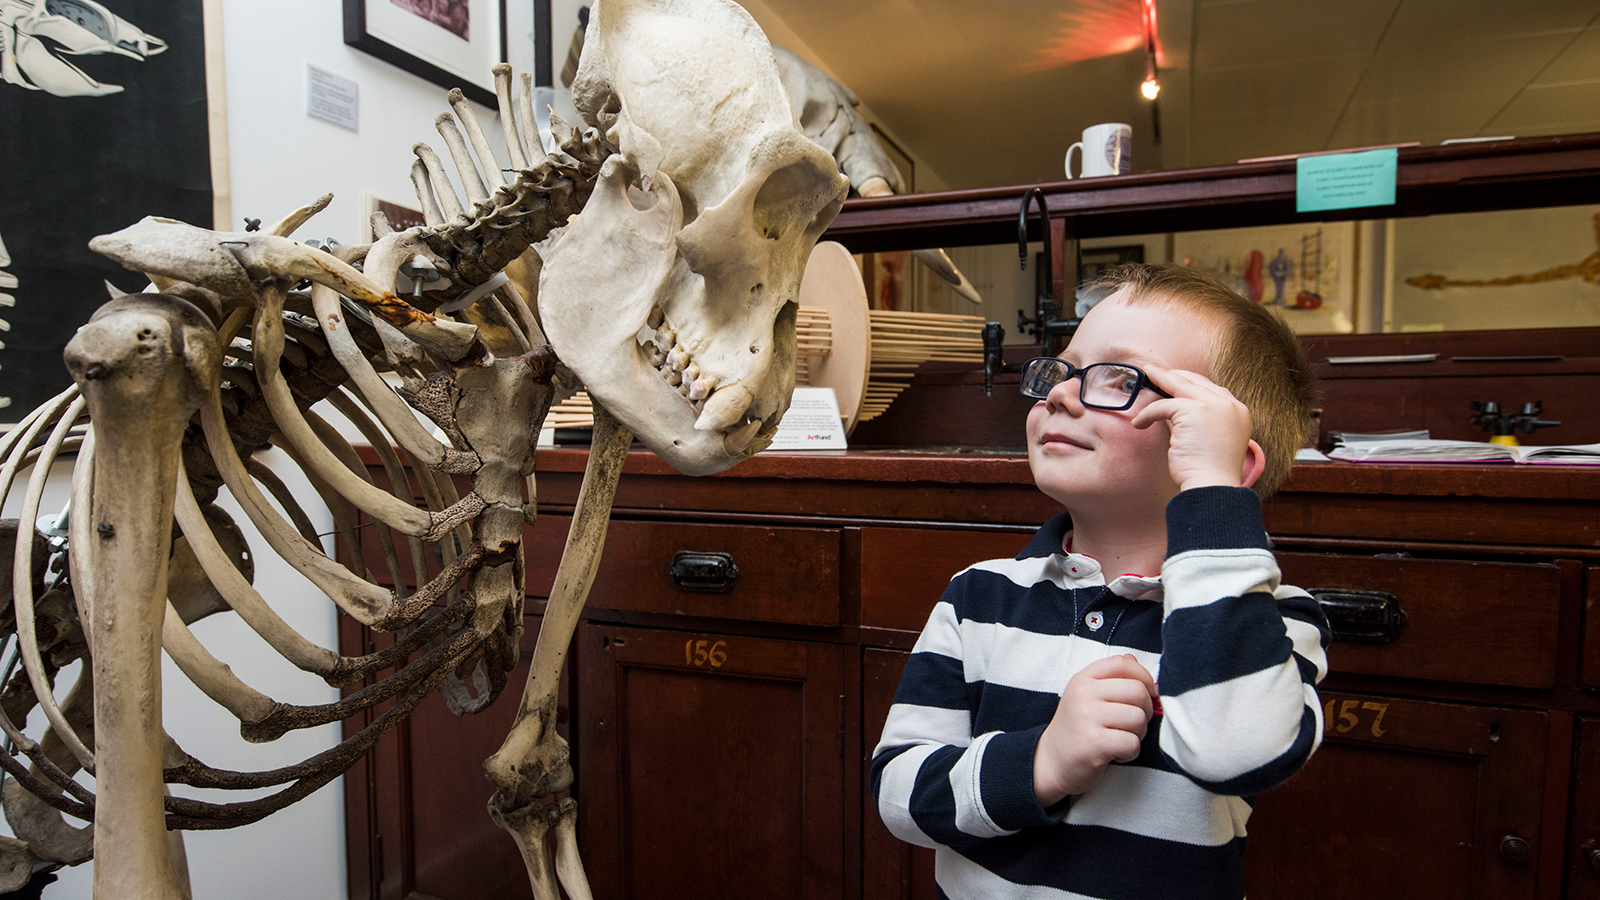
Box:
872;577;1067;849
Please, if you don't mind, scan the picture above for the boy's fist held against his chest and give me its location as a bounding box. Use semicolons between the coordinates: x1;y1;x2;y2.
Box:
1034;653;1155;806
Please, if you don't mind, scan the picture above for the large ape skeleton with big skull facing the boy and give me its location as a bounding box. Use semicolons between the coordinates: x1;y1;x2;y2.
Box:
0;0;846;900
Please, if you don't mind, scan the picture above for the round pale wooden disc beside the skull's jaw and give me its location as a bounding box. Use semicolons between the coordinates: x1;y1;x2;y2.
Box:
800;240;872;434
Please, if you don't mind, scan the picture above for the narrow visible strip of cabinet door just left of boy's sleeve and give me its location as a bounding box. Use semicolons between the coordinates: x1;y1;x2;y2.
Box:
861;649;936;900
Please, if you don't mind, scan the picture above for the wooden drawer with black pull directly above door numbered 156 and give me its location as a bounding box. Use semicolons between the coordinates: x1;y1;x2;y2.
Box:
528;516;840;626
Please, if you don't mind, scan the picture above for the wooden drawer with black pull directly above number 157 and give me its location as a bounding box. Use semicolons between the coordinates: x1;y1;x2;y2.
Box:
1277;552;1562;687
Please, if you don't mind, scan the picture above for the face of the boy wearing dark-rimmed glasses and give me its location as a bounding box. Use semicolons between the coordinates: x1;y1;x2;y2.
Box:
1027;291;1218;516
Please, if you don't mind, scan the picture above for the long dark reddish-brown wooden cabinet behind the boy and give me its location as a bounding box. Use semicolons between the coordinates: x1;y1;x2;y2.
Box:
347;450;1600;900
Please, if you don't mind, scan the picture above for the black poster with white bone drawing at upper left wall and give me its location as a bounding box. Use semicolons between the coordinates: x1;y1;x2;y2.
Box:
0;0;227;416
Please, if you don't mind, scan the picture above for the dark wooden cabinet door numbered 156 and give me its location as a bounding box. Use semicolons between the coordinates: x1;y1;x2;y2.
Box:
578;623;859;900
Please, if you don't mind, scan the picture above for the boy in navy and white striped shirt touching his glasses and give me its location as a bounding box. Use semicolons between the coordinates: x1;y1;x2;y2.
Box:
872;264;1330;900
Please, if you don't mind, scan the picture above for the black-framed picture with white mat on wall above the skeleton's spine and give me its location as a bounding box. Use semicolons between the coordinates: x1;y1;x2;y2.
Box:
344;0;512;109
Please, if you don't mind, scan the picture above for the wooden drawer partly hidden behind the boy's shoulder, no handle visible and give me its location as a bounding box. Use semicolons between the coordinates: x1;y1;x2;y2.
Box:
861;528;1032;631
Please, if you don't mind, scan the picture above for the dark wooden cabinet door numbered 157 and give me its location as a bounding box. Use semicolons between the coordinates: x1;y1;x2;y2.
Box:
1245;692;1558;900
